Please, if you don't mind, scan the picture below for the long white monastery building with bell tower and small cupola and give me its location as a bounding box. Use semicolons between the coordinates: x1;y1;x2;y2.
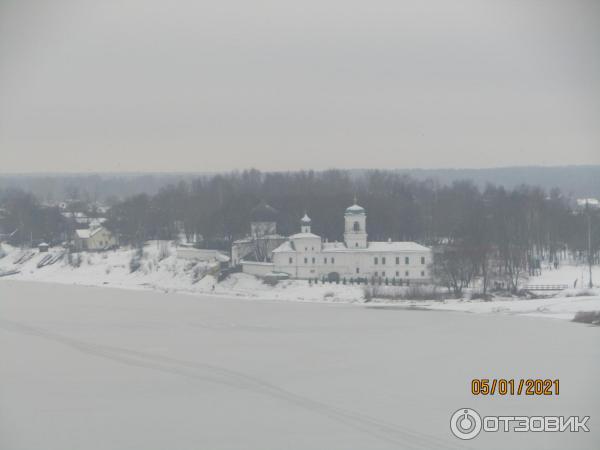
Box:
243;204;432;282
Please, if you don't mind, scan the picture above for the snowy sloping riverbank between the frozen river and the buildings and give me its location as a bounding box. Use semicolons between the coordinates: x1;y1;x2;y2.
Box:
0;242;600;320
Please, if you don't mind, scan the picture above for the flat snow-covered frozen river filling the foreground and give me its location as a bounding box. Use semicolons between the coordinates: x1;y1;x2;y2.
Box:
0;280;600;450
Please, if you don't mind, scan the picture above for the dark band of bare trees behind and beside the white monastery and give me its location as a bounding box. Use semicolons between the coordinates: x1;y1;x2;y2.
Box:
0;170;600;292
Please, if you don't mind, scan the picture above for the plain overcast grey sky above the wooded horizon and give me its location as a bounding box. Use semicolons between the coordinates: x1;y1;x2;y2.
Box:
0;0;600;173
